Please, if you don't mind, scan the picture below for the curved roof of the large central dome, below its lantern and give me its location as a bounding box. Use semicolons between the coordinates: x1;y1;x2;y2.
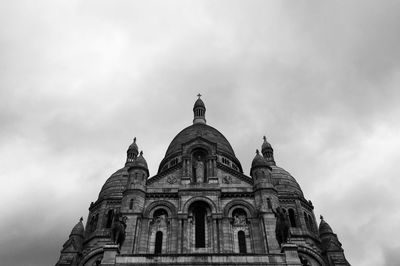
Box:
165;123;236;158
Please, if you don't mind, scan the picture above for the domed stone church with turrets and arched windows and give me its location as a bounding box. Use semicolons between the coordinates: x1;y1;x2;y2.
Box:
56;95;350;266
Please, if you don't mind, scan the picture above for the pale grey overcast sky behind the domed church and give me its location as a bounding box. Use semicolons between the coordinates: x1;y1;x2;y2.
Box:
0;0;400;266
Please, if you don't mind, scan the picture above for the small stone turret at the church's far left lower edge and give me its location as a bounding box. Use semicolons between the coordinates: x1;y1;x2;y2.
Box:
56;217;85;266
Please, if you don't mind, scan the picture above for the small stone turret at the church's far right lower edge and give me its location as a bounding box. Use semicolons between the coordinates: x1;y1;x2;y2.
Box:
318;215;350;266
